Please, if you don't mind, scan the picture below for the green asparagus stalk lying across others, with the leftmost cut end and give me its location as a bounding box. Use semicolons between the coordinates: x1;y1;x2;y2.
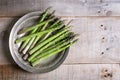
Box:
15;27;62;43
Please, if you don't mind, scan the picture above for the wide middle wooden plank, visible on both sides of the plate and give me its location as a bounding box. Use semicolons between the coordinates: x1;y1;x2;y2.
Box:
0;17;120;64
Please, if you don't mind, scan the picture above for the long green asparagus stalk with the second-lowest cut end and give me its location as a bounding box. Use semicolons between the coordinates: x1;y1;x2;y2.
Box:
28;32;69;61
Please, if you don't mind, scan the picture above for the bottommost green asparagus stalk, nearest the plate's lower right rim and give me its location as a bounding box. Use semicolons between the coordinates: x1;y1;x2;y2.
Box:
31;39;78;66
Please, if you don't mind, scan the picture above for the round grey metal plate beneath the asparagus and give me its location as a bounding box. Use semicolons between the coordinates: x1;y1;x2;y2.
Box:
9;11;69;73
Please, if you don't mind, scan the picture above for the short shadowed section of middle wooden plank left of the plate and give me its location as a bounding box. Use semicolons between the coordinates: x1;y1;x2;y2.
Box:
0;18;18;64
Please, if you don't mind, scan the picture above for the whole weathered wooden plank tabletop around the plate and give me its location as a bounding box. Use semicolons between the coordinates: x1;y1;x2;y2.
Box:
0;0;120;80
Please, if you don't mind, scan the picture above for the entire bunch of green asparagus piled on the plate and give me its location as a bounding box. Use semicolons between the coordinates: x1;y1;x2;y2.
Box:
15;8;78;66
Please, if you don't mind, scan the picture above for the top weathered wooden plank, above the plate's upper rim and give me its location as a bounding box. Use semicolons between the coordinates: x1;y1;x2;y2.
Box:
0;0;120;16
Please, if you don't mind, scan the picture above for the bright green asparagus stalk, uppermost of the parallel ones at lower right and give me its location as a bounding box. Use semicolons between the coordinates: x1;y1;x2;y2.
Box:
29;29;68;54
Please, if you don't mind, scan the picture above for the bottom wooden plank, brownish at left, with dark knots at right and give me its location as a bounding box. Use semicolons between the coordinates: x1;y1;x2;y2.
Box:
0;64;120;80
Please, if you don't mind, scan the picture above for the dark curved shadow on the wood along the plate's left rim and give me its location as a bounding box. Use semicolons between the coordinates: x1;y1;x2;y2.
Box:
1;18;18;64
